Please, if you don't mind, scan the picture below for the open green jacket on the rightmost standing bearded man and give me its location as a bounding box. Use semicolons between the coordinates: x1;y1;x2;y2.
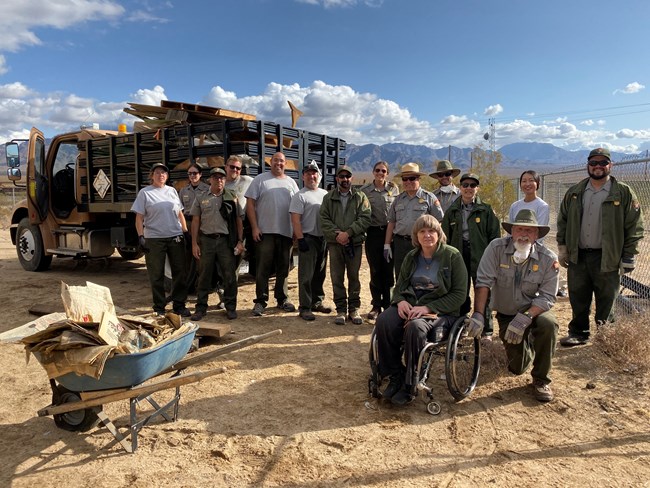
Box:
557;176;643;273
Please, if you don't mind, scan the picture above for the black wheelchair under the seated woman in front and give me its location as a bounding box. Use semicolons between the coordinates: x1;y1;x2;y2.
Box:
368;316;481;415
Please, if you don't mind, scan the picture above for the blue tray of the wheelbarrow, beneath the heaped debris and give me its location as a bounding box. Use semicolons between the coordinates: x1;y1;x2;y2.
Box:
55;324;199;392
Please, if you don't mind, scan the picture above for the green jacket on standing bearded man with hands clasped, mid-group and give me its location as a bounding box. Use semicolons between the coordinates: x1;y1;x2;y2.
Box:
320;188;371;245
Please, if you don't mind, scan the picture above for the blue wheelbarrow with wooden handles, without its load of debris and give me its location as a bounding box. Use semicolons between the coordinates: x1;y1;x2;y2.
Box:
38;326;282;453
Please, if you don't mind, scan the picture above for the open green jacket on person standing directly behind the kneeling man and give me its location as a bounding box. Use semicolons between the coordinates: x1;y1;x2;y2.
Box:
442;196;501;276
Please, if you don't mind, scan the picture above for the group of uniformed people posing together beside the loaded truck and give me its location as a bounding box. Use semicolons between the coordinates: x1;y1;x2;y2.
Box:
132;148;643;405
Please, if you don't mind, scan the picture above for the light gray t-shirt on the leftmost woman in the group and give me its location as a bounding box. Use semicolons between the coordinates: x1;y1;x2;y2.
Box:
131;185;183;239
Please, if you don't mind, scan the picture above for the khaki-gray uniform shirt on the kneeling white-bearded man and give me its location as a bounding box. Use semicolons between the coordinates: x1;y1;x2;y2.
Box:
476;236;560;315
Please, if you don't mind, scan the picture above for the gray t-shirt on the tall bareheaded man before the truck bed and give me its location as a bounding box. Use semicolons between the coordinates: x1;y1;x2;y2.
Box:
245;171;298;237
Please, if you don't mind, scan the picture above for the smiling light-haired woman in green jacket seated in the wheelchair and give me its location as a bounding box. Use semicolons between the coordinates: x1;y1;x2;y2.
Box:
375;215;467;405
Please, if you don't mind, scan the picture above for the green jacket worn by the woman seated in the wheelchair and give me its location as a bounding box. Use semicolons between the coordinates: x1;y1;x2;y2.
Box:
391;244;467;315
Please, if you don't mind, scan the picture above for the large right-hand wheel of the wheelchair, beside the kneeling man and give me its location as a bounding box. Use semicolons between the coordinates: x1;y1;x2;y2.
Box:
445;317;481;401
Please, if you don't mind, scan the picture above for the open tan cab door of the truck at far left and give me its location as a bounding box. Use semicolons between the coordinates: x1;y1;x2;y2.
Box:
27;128;50;224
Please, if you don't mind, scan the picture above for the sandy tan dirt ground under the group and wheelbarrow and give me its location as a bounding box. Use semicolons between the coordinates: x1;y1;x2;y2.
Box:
0;229;650;488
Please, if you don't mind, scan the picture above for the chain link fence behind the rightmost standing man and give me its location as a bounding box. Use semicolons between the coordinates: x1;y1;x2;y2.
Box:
507;152;650;315
